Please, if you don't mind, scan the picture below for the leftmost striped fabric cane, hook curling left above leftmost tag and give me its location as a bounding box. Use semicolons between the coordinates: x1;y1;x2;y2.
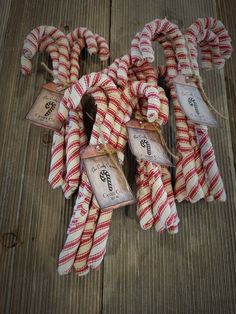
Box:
21;26;72;191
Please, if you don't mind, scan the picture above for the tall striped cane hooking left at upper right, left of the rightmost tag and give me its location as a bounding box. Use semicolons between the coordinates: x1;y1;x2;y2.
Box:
131;19;209;202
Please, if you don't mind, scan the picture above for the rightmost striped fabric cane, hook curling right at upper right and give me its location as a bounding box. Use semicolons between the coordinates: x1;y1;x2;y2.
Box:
185;17;232;201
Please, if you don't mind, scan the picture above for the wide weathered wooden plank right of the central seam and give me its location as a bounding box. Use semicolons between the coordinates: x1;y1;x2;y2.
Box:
103;1;236;314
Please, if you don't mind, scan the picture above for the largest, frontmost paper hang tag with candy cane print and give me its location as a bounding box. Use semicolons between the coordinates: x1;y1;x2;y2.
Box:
81;145;135;210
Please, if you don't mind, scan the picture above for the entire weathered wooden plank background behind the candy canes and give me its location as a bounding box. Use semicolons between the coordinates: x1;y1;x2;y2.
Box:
0;0;236;314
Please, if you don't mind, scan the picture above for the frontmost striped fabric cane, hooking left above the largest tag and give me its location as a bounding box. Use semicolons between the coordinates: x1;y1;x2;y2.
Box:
58;73;124;274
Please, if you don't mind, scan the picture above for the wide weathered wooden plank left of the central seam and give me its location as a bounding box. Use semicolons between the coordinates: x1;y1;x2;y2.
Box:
0;0;110;314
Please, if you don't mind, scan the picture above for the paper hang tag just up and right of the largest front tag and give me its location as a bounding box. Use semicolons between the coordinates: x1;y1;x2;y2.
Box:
126;120;172;166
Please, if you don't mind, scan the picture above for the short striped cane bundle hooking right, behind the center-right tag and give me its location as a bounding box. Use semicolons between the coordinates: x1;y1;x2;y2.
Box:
122;82;178;231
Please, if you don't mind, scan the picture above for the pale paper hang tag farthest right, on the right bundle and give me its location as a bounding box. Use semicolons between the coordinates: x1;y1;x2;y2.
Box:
174;75;219;128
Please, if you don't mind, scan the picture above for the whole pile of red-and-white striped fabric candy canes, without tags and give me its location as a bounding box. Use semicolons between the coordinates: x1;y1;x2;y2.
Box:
21;17;232;276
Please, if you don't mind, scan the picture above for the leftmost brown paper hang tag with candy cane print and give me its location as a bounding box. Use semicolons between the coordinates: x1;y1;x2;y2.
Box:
26;83;63;131
